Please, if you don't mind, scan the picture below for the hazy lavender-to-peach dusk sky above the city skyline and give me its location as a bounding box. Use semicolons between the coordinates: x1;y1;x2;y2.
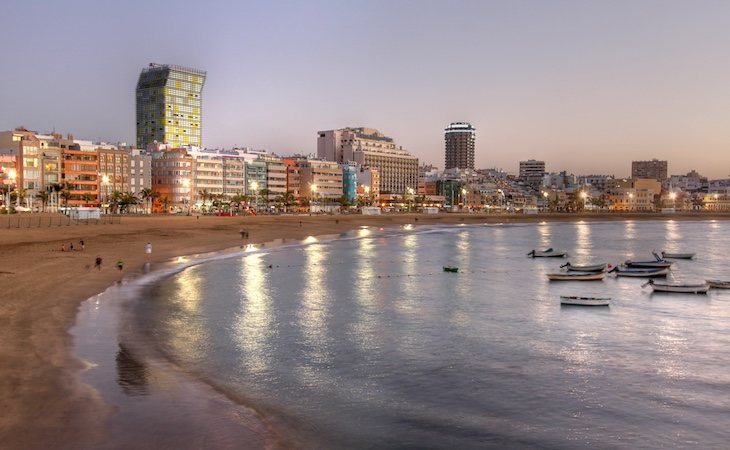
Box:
0;0;730;178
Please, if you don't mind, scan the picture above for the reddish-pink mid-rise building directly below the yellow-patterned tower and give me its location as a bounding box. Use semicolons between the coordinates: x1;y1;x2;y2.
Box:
152;148;194;212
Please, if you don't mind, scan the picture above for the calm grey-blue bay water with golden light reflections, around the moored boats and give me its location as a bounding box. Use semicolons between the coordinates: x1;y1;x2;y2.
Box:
74;221;730;449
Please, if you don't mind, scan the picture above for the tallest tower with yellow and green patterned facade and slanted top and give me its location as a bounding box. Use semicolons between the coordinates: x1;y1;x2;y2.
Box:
137;63;205;148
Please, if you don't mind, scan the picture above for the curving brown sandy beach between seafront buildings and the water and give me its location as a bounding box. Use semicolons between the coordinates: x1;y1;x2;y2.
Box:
0;214;730;449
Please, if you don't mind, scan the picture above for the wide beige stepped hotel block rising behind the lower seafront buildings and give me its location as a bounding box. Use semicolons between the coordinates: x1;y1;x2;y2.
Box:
317;127;418;194
